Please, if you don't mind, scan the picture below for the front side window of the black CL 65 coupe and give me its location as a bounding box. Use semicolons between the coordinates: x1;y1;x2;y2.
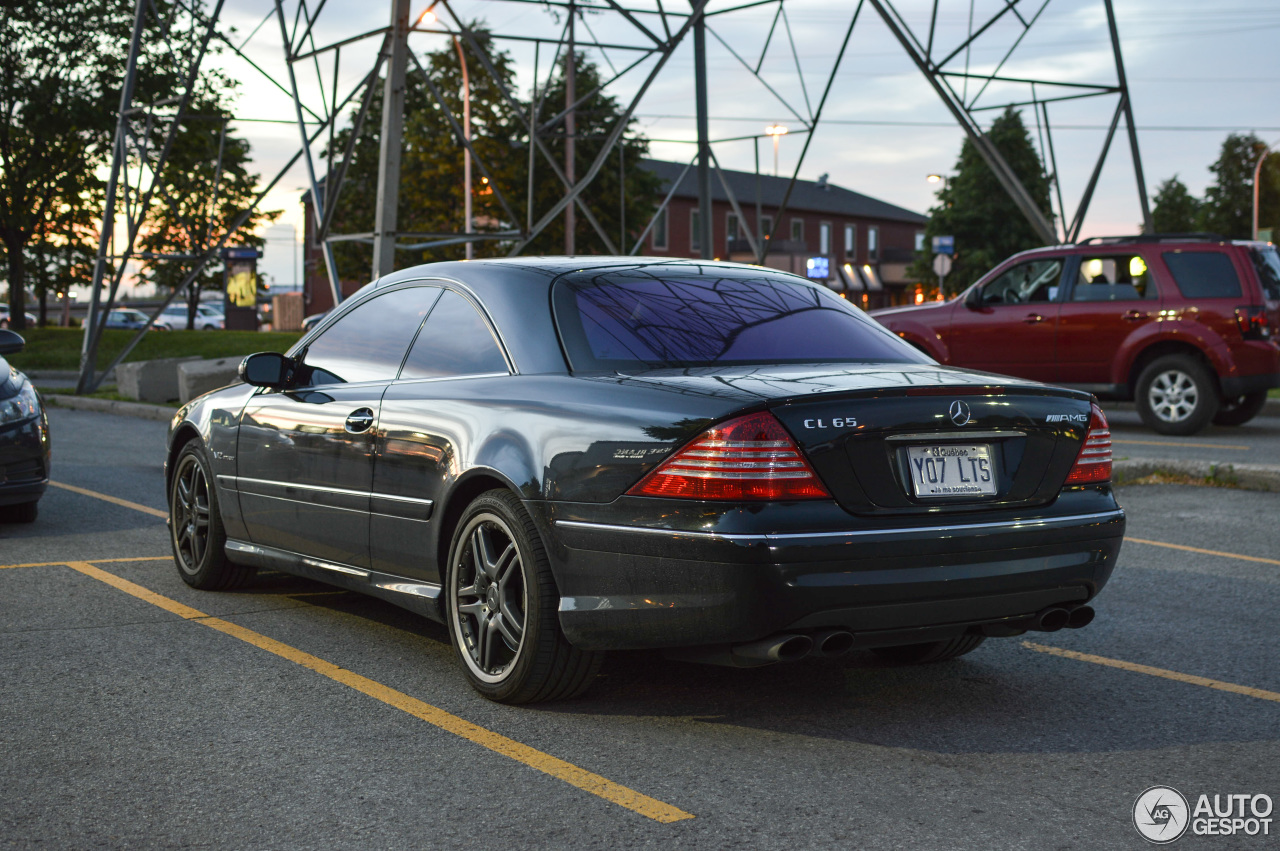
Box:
294;287;440;386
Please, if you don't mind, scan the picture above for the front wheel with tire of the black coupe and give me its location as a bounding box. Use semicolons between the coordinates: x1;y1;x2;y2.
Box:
169;440;257;591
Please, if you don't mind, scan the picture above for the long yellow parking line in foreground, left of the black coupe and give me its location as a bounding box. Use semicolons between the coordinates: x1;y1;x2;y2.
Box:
67;562;694;824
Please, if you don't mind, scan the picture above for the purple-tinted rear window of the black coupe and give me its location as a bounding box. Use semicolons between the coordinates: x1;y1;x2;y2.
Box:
554;266;929;371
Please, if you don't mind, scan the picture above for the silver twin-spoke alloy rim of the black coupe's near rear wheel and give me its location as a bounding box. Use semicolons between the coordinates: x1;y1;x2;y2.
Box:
449;513;527;682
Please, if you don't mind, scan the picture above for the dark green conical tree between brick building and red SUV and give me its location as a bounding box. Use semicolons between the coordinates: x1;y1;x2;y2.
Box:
908;106;1053;294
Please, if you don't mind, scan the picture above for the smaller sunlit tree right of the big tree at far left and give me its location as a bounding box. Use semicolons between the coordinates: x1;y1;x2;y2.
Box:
138;84;282;330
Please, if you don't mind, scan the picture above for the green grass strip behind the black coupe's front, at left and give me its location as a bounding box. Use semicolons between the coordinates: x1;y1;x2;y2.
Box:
5;328;302;370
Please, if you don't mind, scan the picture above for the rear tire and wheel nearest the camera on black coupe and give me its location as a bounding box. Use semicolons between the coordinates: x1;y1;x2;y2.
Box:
445;490;604;704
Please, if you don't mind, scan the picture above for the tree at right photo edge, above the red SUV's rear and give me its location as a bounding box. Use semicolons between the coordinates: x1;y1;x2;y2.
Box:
1199;133;1280;239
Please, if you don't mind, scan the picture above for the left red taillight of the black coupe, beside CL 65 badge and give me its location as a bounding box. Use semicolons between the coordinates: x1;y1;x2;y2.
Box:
627;412;831;500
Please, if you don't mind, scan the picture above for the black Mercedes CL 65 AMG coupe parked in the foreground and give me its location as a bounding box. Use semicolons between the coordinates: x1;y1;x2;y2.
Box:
166;257;1125;703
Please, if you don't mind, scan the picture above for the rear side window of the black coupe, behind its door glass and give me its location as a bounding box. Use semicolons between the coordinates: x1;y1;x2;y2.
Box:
401;290;508;379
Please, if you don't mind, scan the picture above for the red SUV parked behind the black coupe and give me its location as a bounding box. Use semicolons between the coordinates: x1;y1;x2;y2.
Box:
872;234;1280;435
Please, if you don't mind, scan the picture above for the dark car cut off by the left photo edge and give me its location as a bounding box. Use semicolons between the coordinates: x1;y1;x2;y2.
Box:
0;329;49;523
